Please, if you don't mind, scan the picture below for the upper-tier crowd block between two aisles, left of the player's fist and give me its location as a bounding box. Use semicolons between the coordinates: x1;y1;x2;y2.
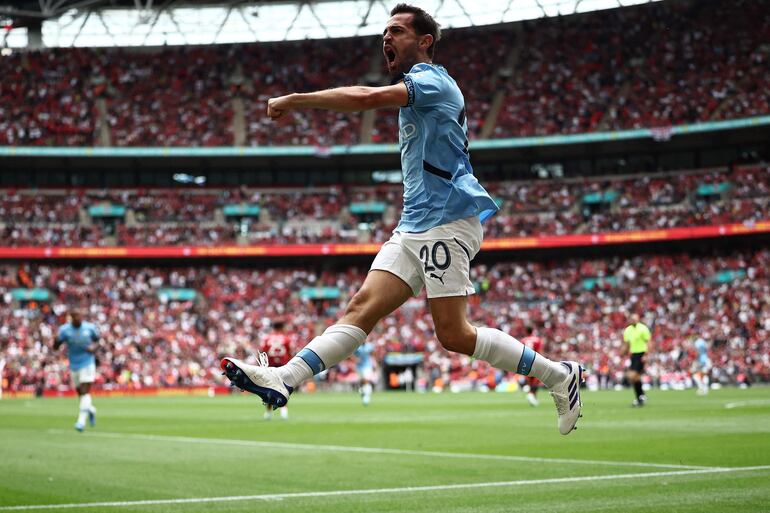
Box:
101;46;236;146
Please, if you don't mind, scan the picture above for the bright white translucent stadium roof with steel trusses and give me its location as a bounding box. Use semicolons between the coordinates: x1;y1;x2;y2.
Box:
0;0;660;47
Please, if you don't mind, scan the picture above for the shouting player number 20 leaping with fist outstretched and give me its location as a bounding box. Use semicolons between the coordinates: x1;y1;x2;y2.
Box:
221;4;583;435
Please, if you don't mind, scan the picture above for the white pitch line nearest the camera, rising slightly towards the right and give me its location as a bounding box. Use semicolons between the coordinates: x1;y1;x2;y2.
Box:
0;465;770;511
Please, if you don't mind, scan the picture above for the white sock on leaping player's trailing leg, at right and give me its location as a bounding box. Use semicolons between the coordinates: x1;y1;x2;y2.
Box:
473;328;567;388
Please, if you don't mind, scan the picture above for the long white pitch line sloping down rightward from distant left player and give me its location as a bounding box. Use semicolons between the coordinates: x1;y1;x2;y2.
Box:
48;429;722;470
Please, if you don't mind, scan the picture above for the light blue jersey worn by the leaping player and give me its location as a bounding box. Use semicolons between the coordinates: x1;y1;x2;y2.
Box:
396;63;498;233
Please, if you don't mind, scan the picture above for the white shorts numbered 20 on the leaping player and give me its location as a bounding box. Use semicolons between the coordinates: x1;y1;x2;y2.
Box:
371;217;484;298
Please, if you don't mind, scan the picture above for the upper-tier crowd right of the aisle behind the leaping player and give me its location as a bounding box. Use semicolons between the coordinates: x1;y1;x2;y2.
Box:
494;0;770;137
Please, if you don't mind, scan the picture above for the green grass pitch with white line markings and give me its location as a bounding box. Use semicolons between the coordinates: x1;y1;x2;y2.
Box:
0;387;770;513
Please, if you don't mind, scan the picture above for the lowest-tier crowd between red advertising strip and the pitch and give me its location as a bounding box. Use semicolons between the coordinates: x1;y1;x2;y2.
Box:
0;247;770;390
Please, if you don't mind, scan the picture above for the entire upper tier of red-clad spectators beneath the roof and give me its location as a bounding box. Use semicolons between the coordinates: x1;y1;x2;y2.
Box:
0;0;770;146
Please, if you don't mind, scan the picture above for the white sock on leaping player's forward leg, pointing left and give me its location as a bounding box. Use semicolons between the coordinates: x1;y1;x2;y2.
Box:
278;324;366;387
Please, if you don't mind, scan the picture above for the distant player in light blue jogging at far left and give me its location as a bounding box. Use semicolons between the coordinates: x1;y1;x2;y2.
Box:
53;310;100;432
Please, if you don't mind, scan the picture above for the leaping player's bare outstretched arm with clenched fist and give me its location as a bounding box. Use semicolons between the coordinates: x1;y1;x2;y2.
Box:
267;82;409;119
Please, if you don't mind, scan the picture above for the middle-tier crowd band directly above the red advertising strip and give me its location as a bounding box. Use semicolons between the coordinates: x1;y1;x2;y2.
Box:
0;165;770;246
